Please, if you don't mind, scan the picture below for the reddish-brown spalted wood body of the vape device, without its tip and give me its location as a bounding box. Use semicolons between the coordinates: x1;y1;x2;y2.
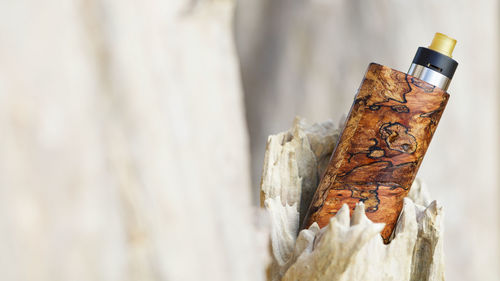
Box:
304;63;449;243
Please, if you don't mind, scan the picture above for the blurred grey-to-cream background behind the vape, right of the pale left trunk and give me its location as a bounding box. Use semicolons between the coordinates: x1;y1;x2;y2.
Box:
235;0;500;281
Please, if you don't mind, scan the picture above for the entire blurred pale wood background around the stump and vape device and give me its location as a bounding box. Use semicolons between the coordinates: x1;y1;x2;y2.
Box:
0;0;500;281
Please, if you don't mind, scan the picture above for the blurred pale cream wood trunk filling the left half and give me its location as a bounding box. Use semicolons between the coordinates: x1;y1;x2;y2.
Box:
0;0;267;281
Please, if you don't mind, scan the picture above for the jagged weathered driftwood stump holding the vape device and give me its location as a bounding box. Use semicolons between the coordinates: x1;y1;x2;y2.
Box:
261;118;444;281
